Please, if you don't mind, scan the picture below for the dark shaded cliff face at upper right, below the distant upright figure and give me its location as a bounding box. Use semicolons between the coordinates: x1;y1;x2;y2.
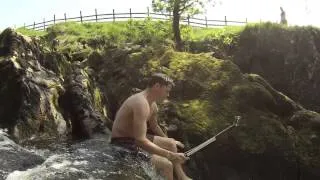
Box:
232;23;320;112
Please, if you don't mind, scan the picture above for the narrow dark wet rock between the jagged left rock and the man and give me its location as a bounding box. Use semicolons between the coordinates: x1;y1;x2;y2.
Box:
59;64;108;138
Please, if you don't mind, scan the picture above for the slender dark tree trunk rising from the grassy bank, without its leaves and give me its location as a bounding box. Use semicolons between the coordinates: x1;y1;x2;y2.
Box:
172;0;183;51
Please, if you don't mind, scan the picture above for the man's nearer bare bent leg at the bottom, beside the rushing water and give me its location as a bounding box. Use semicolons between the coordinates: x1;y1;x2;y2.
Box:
151;154;173;180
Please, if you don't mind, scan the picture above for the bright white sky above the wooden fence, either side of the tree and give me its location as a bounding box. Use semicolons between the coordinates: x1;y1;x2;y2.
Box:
0;0;320;31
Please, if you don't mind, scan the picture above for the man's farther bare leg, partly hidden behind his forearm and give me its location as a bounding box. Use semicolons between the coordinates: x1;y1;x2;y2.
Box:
153;136;191;180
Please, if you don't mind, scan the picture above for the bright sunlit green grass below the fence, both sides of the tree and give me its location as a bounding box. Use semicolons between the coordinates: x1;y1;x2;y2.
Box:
17;18;248;49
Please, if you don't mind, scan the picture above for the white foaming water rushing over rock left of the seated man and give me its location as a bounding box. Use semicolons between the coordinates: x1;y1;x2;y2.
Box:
0;131;162;180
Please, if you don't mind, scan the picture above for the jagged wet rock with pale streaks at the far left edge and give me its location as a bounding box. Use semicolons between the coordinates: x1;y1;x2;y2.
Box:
0;29;66;139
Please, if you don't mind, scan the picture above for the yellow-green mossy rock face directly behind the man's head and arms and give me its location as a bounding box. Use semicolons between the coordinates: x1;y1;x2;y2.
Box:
149;50;245;139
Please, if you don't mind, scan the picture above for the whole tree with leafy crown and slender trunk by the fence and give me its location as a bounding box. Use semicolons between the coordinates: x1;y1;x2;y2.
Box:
152;0;212;51
